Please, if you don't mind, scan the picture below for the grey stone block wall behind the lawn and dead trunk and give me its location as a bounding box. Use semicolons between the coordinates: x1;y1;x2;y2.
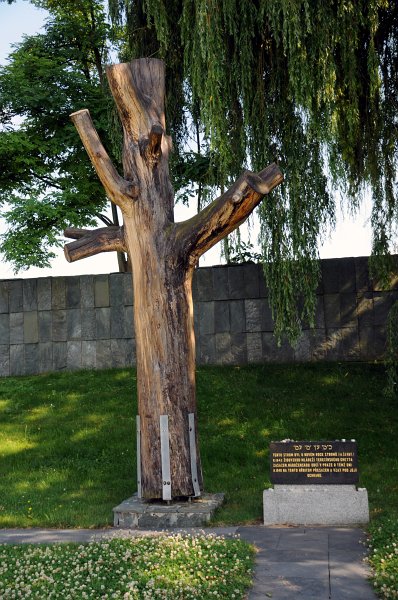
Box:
0;257;398;376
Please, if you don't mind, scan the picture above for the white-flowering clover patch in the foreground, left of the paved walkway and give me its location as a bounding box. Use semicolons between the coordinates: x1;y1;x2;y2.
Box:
0;535;253;600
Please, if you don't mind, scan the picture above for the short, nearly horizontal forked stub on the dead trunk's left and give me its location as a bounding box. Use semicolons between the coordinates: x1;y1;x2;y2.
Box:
64;227;127;262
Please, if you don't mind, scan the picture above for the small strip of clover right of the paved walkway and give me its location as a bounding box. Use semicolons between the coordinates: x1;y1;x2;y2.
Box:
369;517;398;599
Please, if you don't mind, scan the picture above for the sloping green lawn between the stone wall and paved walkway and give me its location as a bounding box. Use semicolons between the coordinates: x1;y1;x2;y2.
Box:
0;364;398;527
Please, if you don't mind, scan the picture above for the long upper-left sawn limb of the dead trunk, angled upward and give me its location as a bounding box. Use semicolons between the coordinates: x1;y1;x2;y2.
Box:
70;109;139;211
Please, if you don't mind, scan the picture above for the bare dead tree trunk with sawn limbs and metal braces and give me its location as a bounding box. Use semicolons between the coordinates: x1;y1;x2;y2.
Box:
65;59;282;499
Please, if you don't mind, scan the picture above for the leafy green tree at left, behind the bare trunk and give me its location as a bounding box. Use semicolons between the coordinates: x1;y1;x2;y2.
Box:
0;0;118;270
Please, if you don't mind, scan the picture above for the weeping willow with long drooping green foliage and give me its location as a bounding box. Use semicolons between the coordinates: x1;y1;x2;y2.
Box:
109;0;398;338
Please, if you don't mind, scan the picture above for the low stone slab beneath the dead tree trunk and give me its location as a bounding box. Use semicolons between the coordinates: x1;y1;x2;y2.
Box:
113;494;224;529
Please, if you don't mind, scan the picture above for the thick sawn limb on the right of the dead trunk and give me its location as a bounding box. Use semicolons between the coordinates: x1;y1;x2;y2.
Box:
176;163;283;263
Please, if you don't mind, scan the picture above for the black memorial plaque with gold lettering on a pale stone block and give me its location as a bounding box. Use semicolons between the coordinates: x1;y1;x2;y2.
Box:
270;441;358;485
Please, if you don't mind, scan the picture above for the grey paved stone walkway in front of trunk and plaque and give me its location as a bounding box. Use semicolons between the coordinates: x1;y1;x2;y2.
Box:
0;526;376;600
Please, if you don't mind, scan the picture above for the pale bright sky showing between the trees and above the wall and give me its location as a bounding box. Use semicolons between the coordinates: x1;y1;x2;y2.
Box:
0;0;371;279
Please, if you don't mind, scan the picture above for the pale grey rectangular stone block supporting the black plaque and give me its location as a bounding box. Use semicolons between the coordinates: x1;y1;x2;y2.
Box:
263;485;369;526
